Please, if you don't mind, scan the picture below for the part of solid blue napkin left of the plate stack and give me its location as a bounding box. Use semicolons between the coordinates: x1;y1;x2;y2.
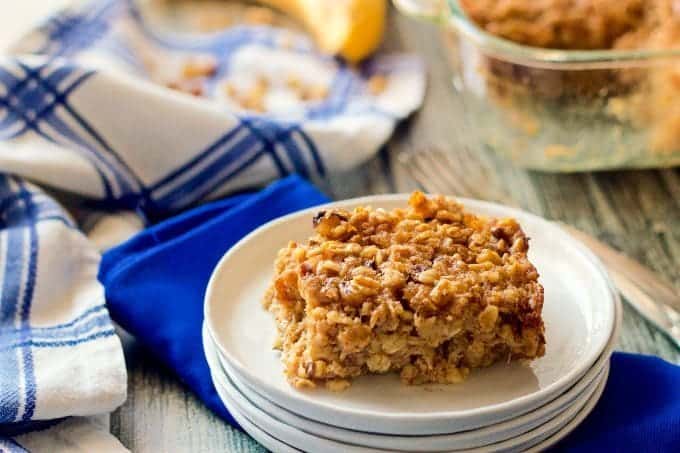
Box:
99;176;328;425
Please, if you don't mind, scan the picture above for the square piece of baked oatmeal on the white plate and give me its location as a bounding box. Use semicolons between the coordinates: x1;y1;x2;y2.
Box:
264;192;545;390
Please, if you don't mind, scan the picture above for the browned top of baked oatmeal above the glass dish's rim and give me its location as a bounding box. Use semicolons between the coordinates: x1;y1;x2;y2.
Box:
460;0;680;50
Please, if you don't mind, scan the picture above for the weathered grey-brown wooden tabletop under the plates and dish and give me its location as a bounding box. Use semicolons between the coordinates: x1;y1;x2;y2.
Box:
111;7;680;452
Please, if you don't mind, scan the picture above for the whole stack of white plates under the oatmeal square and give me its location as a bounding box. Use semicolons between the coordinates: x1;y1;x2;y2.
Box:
203;195;621;453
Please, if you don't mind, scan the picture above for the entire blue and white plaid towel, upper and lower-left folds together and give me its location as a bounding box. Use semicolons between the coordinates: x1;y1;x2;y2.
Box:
0;0;425;451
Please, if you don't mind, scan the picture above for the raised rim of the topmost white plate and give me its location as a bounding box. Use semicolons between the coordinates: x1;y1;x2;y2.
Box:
204;193;620;423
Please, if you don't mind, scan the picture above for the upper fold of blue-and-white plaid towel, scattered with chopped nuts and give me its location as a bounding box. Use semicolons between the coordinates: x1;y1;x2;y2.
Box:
0;0;425;217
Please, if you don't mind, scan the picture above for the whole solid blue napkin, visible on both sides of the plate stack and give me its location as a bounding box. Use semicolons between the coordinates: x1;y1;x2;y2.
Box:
99;177;680;451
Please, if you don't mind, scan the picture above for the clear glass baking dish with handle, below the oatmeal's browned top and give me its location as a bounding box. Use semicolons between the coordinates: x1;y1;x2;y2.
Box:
394;0;680;172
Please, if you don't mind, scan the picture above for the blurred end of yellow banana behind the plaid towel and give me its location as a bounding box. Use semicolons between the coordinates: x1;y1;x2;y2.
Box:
259;0;387;62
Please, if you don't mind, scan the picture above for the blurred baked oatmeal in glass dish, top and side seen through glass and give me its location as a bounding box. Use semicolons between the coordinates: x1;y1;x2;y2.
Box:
460;0;680;161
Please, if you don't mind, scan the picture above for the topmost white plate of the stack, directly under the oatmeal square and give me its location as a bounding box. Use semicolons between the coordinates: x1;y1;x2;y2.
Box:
205;195;617;435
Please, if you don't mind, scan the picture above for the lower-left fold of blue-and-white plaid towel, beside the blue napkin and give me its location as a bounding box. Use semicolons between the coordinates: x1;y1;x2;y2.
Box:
0;175;127;442
